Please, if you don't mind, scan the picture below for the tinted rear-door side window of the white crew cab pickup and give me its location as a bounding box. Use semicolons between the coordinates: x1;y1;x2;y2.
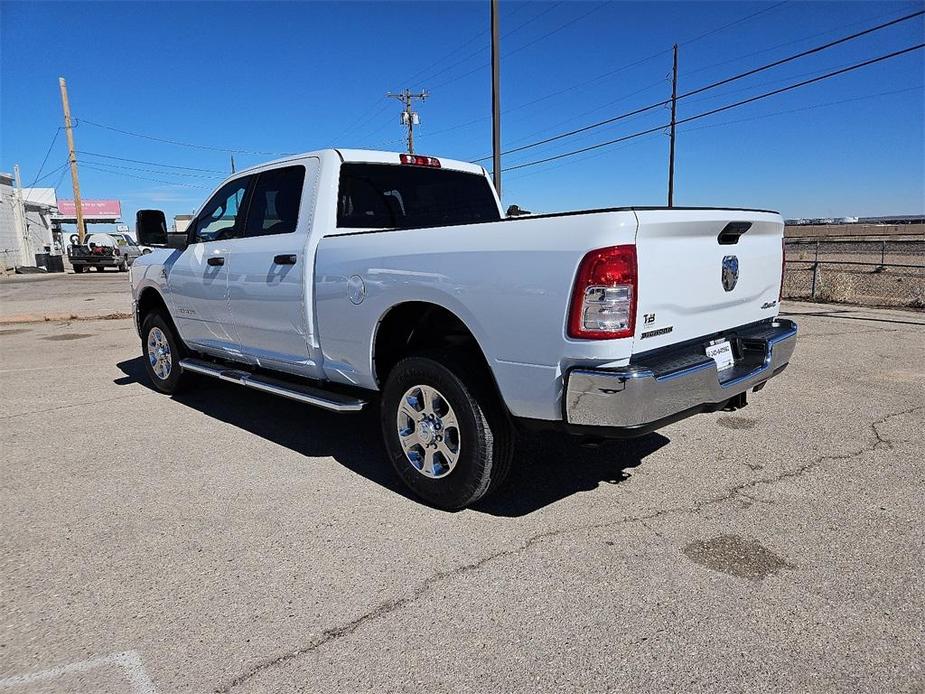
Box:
244;166;305;237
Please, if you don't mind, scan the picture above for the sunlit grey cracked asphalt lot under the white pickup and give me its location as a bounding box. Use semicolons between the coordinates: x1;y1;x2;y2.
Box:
0;303;925;694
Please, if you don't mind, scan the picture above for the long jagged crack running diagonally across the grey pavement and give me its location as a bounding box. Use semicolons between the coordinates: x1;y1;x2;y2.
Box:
214;406;925;694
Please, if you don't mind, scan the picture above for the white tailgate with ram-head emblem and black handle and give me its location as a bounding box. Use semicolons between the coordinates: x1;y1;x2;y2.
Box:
633;208;784;353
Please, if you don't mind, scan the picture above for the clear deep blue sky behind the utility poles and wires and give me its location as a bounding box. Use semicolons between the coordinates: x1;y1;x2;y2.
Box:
0;0;925;227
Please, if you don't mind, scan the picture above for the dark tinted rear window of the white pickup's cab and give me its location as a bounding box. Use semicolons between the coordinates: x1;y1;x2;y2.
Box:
337;163;501;229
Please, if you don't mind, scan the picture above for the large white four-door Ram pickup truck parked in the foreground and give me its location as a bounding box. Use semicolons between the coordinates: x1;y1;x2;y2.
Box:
131;149;797;509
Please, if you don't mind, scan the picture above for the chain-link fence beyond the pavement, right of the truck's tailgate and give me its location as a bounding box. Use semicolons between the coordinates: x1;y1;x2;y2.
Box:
784;235;925;310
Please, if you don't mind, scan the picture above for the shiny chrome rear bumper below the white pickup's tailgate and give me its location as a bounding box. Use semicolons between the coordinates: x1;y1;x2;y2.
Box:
565;318;797;430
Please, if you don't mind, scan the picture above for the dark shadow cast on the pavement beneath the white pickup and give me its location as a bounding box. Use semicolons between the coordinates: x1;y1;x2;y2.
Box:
115;357;669;517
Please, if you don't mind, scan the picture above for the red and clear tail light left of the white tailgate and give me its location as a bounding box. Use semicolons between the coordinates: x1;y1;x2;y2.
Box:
568;245;637;340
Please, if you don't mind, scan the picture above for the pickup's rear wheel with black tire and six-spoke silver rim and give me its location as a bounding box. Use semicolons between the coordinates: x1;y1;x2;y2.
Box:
380;355;513;510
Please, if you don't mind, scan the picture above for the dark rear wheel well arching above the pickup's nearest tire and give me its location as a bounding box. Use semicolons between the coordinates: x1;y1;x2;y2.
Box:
373;301;494;386
